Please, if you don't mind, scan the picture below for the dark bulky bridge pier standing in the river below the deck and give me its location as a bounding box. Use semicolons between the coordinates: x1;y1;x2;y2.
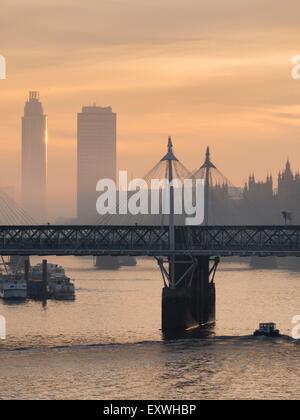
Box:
160;256;219;333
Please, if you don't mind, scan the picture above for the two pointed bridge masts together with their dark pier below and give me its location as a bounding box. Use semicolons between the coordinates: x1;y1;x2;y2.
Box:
158;138;219;334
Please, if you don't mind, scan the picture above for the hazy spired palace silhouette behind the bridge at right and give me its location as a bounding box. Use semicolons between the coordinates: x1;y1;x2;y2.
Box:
210;160;300;225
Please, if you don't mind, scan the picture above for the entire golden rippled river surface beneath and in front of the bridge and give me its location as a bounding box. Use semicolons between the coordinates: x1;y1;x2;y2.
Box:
0;257;300;399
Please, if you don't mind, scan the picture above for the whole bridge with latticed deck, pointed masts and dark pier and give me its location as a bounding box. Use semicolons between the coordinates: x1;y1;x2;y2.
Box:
0;142;300;333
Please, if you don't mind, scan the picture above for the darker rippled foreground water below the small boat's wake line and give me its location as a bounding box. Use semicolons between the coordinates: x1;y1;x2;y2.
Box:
0;337;300;399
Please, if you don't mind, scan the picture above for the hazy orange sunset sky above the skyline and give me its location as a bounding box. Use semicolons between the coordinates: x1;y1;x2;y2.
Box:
0;0;300;218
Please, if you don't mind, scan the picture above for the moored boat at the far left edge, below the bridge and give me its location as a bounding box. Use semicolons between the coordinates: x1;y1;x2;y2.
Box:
0;273;27;300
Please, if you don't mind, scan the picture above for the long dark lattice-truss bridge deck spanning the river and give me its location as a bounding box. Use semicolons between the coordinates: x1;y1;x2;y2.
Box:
0;225;300;257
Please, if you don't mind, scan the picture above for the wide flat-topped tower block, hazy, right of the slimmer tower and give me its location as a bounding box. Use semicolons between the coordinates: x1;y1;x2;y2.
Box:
77;105;117;223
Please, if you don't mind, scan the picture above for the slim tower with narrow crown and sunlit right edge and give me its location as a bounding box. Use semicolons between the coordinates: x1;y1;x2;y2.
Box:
22;92;47;222
